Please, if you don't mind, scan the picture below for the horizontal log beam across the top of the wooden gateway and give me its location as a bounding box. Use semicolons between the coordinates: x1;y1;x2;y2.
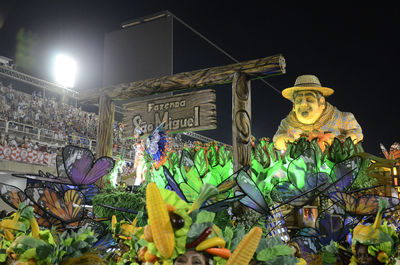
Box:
79;54;286;103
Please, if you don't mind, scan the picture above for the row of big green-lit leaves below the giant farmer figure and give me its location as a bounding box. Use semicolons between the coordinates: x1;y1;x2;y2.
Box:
150;136;376;212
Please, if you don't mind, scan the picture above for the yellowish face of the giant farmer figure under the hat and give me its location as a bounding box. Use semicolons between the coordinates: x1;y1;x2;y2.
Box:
293;91;325;124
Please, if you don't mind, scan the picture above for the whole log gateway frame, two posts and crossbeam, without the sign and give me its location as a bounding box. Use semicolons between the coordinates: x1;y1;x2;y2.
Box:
80;54;286;171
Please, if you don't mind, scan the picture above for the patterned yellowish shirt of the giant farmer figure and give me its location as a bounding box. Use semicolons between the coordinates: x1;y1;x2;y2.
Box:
273;103;363;142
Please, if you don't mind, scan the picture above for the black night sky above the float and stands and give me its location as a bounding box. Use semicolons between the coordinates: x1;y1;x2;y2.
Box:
0;0;400;155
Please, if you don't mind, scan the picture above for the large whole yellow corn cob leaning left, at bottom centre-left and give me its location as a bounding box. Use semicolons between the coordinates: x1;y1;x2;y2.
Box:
146;183;175;259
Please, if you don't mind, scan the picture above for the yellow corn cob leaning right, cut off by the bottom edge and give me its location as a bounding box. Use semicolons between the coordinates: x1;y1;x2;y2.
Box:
225;226;262;265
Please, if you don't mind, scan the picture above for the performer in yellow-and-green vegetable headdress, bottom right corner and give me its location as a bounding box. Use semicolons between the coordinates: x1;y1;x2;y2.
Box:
350;200;399;265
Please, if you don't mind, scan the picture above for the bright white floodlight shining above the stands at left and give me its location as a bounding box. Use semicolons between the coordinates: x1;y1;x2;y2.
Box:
54;54;76;88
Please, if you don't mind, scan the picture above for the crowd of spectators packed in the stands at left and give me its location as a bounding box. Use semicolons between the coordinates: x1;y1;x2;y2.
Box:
0;80;130;156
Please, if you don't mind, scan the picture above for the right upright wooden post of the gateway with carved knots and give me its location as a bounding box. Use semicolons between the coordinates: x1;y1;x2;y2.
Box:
232;72;251;171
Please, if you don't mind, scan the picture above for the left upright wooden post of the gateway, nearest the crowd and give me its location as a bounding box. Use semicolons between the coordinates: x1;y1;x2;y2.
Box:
96;96;115;158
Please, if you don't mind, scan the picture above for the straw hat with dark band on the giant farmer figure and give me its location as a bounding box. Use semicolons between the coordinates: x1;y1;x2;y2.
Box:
282;75;335;100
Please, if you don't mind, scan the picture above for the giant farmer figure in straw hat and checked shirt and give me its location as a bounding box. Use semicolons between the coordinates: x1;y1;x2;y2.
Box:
273;75;363;150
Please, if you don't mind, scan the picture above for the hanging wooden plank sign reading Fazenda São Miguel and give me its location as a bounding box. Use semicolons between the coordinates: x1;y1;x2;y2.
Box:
123;89;217;137
